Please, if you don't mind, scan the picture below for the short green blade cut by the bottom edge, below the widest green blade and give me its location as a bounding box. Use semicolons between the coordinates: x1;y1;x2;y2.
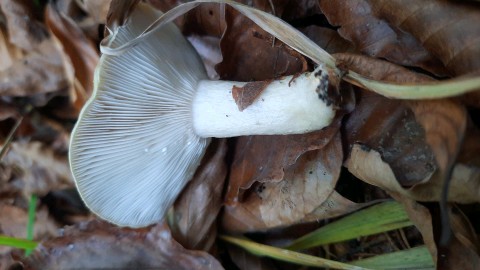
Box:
350;246;435;270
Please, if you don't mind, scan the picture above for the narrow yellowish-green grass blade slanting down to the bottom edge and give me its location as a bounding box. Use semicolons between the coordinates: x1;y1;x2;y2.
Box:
220;236;368;270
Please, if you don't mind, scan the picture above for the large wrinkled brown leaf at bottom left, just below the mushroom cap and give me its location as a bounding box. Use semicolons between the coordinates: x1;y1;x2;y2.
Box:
16;221;223;270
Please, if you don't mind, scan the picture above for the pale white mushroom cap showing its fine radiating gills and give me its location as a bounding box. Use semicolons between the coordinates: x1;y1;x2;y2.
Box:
69;4;209;227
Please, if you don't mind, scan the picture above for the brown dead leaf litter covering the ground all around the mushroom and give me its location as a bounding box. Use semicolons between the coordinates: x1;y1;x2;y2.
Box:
0;0;480;269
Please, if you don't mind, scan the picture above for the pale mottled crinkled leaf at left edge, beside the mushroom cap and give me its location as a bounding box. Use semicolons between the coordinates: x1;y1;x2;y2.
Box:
2;142;74;198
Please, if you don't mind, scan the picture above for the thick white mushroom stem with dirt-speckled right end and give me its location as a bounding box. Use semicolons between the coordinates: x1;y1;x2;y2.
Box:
192;67;335;138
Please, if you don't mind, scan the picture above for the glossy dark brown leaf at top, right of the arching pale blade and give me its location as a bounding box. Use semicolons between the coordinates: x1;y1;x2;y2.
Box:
320;0;446;75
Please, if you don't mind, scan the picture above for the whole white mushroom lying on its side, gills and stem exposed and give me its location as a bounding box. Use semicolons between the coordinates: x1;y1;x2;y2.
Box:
69;3;335;227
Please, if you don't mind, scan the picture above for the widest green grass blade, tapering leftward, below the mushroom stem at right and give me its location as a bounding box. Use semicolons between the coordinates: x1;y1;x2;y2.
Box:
287;201;413;250
